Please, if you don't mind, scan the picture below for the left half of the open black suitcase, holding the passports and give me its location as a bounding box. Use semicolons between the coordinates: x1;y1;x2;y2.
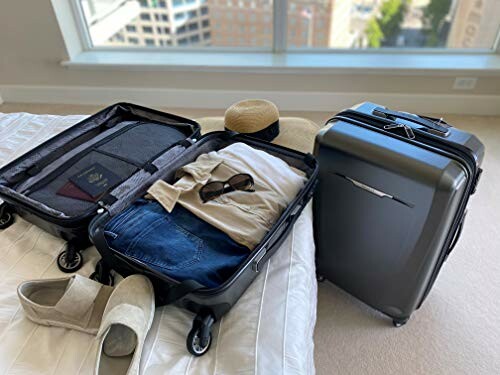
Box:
0;103;200;272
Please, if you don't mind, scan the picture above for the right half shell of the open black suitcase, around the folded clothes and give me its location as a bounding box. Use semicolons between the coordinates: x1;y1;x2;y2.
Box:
89;132;319;356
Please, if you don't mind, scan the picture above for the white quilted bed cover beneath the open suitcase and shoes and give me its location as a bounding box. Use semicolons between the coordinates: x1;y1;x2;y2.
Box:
0;113;317;374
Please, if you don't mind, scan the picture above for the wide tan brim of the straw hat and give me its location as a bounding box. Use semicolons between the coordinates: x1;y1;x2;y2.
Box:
196;117;320;152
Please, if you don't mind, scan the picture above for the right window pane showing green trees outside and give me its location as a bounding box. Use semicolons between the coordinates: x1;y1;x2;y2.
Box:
288;0;500;48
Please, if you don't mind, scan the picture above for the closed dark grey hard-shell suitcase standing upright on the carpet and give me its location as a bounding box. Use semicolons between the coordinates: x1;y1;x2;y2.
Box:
314;103;484;326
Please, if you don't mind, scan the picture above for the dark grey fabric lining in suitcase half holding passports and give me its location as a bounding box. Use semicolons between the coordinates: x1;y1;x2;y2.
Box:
10;121;186;217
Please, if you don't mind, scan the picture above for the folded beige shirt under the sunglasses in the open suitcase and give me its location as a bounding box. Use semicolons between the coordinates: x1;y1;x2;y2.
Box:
146;143;306;249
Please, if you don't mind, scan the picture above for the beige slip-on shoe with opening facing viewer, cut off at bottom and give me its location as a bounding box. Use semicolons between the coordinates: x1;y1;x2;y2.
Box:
94;275;155;375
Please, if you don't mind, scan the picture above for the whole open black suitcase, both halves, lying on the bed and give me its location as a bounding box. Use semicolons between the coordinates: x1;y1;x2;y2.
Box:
0;103;318;355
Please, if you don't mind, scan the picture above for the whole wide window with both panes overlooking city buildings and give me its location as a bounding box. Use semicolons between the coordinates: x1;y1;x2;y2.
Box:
75;0;500;52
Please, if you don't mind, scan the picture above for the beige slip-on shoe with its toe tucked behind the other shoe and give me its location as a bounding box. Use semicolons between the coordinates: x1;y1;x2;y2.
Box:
17;275;113;335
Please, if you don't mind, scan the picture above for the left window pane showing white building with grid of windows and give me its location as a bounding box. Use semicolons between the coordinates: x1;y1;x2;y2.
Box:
77;0;273;48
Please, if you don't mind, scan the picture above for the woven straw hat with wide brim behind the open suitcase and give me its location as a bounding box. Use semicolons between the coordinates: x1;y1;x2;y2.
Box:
197;100;320;153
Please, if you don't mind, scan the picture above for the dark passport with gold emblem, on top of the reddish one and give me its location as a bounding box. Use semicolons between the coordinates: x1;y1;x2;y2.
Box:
69;163;121;199
